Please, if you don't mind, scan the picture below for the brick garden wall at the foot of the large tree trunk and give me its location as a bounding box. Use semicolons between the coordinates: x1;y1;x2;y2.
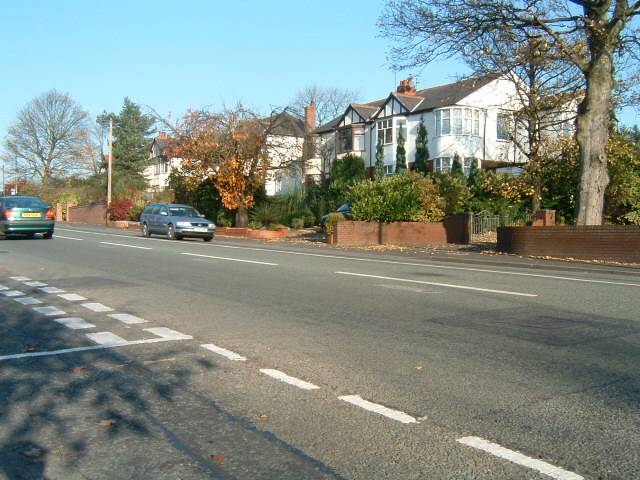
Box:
497;225;640;263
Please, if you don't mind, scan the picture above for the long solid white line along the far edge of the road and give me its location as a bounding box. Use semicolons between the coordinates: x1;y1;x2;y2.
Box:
60;229;640;287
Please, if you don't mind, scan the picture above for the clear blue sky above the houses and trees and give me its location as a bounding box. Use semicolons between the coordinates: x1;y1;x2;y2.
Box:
0;0;637;156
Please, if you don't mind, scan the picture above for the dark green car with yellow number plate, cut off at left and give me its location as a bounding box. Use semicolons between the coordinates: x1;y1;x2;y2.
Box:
0;195;55;238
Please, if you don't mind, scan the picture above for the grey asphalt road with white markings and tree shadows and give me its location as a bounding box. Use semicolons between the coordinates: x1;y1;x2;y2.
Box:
0;225;640;480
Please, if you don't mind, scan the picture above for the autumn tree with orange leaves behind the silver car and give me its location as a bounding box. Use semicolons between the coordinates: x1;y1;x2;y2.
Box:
168;106;270;227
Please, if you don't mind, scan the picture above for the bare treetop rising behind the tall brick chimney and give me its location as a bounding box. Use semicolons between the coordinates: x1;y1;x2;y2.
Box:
287;85;360;125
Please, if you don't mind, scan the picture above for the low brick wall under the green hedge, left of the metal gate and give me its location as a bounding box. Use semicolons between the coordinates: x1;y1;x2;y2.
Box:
332;214;470;246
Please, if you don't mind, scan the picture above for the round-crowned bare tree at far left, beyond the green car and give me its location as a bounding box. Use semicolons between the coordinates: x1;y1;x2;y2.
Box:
5;90;89;188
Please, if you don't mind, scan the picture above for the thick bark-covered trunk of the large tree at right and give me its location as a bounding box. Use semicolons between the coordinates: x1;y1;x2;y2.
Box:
576;52;613;225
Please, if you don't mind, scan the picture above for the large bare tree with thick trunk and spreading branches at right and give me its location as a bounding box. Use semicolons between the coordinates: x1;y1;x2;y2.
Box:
379;0;640;225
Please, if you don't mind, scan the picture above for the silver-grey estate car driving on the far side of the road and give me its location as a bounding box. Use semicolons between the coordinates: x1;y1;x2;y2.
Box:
140;203;216;242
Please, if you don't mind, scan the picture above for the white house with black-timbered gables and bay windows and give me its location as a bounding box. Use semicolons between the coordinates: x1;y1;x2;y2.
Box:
315;75;527;174
